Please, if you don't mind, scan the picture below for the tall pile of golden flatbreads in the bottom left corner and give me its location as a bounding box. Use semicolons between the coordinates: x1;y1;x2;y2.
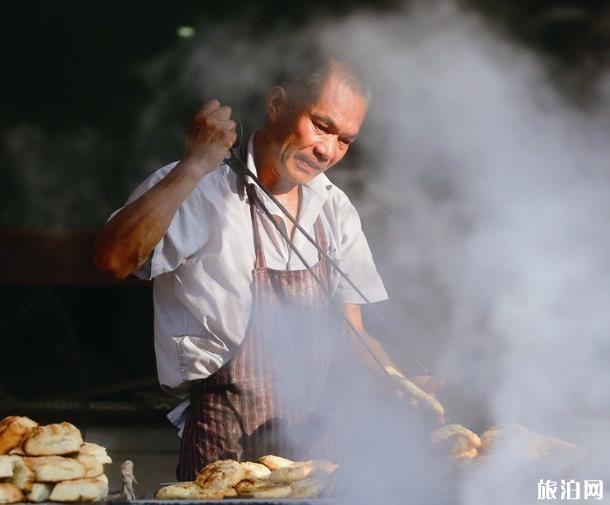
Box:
0;416;112;503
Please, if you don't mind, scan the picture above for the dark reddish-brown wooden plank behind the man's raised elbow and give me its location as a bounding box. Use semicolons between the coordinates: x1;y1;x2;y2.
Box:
0;228;150;286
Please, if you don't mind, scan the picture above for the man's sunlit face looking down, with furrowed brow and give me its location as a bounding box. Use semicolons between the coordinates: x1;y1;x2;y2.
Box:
273;74;367;184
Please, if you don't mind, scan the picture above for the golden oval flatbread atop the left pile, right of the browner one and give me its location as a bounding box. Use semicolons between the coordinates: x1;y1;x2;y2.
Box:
23;422;83;456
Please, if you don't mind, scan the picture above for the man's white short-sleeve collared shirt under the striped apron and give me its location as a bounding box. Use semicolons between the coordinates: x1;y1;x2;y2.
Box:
119;141;387;394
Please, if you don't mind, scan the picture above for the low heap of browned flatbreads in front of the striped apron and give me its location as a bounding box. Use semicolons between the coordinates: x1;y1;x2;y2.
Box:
155;455;338;500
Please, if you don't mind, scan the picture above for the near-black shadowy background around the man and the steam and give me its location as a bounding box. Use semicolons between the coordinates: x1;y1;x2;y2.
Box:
0;0;610;418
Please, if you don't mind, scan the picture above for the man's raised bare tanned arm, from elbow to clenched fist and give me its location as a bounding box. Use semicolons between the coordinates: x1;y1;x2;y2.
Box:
95;100;236;279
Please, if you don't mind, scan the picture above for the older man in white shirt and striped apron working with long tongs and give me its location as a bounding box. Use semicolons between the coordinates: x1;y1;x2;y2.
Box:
96;50;432;480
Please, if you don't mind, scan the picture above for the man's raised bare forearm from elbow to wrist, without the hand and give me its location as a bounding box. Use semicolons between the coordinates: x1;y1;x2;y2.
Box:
95;162;213;279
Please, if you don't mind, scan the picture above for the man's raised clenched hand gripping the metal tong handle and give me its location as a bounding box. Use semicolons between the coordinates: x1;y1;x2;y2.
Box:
183;99;237;173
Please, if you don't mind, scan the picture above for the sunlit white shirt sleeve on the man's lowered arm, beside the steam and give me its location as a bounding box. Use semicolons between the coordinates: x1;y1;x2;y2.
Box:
334;201;388;304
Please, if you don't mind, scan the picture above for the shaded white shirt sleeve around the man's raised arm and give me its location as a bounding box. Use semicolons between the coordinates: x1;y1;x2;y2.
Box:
111;162;211;280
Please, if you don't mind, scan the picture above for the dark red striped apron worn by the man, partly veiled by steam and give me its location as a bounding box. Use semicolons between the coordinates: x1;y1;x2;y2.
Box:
177;185;334;481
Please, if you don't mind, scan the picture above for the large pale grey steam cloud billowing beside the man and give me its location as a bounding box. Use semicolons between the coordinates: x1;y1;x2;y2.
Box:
149;2;610;505
